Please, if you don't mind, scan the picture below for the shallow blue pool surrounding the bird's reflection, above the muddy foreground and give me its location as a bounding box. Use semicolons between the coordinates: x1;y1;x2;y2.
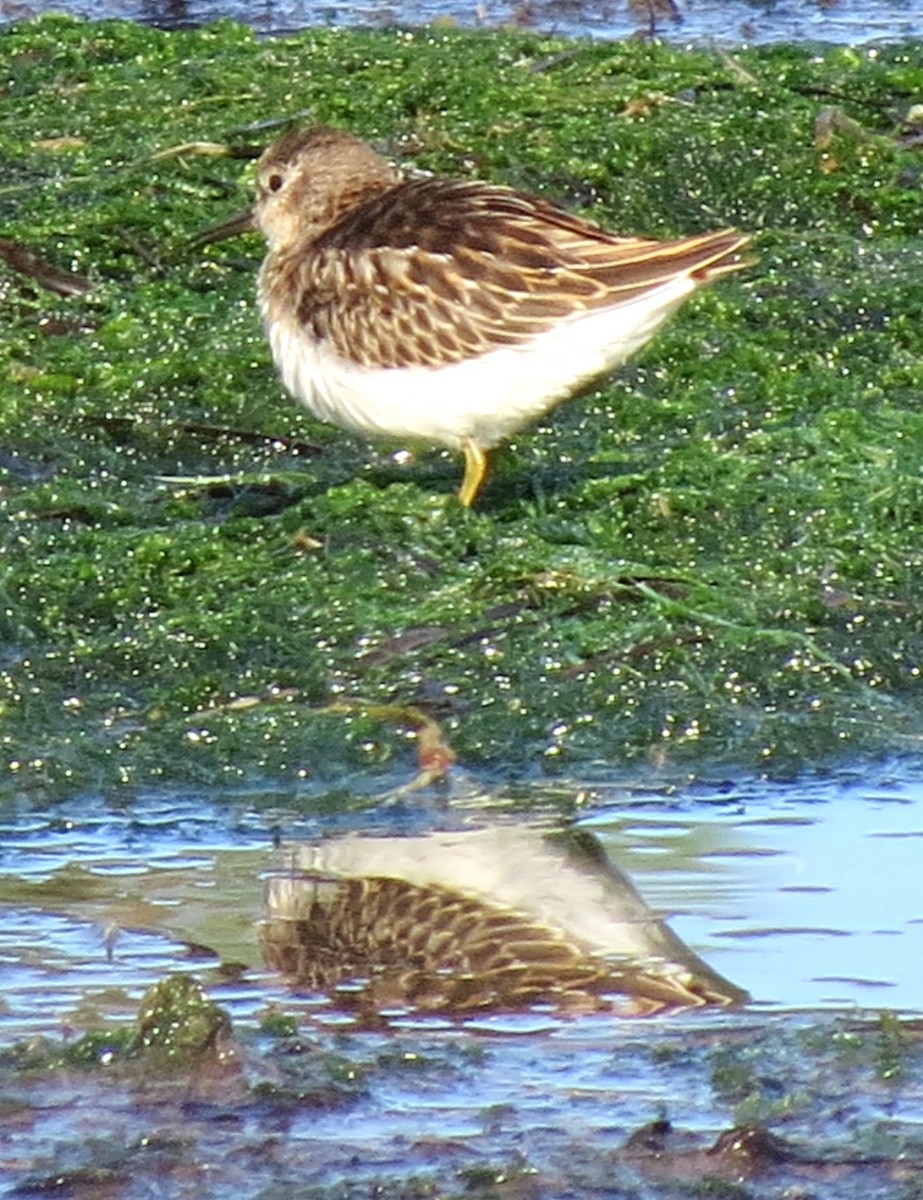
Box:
0;763;923;1042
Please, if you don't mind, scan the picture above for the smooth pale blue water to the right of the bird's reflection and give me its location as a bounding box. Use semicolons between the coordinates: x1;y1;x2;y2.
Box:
589;778;923;1012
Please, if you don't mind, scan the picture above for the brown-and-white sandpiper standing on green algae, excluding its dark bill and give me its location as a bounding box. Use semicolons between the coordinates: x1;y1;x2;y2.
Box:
240;126;748;506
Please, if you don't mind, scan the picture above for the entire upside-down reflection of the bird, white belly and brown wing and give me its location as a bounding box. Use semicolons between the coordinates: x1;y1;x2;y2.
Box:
260;827;745;1013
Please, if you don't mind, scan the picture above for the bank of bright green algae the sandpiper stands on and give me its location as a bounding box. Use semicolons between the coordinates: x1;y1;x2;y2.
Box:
0;17;923;794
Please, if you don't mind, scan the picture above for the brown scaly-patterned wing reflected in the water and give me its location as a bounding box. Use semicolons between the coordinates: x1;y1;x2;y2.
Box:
259;876;738;1014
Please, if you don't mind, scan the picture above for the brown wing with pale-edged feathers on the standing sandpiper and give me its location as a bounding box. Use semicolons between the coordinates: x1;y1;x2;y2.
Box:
290;179;747;367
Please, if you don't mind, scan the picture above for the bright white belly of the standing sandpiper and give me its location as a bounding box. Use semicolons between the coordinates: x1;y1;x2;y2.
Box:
259;276;695;450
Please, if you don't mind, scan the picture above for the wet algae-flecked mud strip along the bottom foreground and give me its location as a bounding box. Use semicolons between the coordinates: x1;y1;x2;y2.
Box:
7;998;923;1200
